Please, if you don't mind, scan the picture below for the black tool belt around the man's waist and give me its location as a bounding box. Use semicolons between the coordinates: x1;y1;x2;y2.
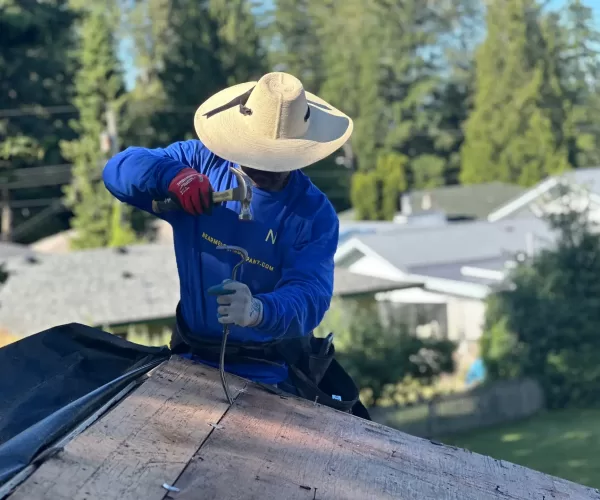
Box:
171;305;370;420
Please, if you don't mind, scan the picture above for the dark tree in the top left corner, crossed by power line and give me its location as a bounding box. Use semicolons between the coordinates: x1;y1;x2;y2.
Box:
0;0;74;168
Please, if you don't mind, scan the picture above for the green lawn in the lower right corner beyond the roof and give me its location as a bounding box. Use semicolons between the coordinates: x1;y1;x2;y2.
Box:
442;410;600;488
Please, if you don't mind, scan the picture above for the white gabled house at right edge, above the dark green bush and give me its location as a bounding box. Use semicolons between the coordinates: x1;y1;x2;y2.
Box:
487;167;600;222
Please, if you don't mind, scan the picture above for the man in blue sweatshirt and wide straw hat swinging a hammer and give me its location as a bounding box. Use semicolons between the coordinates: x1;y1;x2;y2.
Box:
103;73;353;389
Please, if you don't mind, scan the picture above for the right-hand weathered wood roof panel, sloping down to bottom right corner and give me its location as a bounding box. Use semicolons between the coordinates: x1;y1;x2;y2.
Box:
171;385;600;500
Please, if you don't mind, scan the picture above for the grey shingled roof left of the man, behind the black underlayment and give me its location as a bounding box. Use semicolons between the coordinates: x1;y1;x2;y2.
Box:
0;245;179;335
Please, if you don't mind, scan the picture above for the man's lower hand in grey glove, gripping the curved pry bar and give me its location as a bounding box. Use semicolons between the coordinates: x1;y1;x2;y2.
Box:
208;280;263;327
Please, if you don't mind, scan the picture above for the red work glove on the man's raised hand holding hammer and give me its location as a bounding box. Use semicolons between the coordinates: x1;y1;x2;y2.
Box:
169;168;213;215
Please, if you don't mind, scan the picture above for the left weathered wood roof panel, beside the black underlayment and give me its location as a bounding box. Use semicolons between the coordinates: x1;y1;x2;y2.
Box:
10;357;245;500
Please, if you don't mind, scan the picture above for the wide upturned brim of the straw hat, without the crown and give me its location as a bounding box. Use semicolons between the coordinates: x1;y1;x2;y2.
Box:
194;82;353;172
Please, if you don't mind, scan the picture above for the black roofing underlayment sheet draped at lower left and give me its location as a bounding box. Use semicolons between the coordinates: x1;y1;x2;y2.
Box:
0;323;170;485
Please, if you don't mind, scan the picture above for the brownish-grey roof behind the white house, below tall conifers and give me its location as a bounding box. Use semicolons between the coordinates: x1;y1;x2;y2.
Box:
338;182;526;221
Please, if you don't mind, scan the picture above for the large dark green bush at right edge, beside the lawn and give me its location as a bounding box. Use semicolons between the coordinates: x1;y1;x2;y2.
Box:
481;184;600;408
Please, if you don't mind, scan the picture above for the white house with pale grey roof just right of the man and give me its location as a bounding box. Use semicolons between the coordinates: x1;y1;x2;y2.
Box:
335;217;554;352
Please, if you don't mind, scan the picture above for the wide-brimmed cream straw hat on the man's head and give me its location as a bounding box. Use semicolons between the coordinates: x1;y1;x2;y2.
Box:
194;72;353;172
